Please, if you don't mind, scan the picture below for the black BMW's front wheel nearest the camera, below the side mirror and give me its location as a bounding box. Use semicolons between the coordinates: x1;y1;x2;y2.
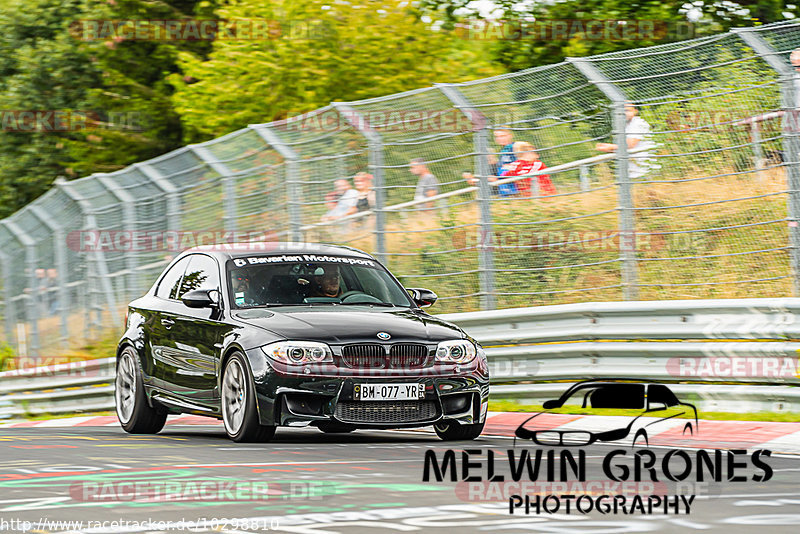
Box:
222;352;275;443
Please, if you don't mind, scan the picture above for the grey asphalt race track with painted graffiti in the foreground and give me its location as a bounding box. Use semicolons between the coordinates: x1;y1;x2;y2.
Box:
0;425;800;534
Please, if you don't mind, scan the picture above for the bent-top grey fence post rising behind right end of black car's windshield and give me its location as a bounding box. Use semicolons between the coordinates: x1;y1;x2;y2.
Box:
331;102;388;265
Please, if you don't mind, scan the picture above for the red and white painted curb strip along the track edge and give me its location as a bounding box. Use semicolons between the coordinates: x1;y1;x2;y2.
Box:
0;412;800;454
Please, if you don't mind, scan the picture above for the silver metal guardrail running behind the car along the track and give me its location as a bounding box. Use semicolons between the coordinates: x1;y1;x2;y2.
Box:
0;298;800;418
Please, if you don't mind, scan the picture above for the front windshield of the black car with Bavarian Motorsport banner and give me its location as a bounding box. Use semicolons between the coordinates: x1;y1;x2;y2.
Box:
227;254;412;308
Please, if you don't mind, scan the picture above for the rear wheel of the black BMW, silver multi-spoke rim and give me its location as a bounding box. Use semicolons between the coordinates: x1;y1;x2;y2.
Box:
114;347;167;434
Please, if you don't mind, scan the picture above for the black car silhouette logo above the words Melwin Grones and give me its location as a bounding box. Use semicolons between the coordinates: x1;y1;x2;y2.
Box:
514;380;698;447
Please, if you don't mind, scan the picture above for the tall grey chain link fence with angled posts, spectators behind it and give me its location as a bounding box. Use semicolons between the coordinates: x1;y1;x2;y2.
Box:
0;23;800;357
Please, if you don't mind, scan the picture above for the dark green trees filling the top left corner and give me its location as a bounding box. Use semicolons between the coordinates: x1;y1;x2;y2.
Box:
0;0;203;217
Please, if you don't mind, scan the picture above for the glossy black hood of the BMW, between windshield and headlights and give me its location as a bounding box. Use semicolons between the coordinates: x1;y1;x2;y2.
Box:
236;307;465;344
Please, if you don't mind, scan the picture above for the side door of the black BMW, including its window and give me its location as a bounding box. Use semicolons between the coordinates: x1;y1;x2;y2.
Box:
152;254;227;407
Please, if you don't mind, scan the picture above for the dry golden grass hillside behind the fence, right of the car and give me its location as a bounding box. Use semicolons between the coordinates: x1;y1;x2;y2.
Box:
314;166;791;313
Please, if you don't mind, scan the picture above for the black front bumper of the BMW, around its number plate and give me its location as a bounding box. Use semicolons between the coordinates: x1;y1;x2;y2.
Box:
248;349;489;429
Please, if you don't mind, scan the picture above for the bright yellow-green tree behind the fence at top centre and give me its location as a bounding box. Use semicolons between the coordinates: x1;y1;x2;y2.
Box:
170;0;500;141
